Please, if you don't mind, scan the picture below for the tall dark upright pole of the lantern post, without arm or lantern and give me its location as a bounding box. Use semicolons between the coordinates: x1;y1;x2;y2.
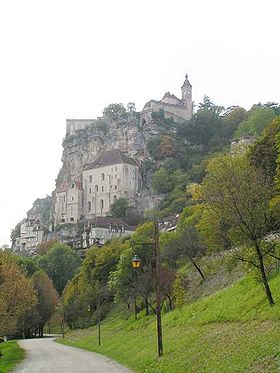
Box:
154;220;163;357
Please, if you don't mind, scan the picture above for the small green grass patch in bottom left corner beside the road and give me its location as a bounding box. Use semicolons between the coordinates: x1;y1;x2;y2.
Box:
0;341;25;373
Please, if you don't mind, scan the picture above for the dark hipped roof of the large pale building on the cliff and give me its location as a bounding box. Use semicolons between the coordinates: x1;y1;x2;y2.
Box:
84;149;137;170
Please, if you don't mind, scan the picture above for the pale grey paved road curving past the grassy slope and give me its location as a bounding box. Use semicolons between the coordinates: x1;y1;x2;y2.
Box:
14;338;132;373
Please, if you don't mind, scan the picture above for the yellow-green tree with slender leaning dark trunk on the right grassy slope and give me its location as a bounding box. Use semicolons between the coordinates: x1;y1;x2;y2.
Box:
201;154;275;305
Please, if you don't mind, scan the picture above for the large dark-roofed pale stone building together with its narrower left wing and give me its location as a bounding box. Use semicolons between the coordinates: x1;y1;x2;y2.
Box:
54;149;140;226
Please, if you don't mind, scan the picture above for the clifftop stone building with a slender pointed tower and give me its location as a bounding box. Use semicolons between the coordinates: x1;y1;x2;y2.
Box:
140;75;192;126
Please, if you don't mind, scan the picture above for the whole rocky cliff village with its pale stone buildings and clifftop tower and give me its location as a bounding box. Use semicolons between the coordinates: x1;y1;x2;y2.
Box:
12;75;193;255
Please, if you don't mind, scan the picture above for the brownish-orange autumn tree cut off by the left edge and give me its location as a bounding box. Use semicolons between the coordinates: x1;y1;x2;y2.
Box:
0;253;37;335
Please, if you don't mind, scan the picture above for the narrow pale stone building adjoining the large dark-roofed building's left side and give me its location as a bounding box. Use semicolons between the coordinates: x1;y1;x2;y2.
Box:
54;181;83;226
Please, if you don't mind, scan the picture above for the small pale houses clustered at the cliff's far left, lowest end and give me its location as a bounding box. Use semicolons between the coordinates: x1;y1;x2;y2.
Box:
13;219;44;255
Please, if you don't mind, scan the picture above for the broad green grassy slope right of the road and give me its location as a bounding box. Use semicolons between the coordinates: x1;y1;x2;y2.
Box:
58;276;280;373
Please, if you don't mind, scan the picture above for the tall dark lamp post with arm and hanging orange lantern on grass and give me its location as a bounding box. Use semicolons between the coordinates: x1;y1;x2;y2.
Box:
131;221;163;357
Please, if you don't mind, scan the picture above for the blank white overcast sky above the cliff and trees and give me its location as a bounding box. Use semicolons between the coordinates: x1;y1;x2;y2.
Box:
0;0;280;246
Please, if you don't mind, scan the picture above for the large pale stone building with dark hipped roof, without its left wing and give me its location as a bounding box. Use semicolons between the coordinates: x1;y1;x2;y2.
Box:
83;149;140;219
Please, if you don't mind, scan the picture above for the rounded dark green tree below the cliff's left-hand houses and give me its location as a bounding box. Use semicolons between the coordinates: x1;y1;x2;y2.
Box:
37;244;81;294
